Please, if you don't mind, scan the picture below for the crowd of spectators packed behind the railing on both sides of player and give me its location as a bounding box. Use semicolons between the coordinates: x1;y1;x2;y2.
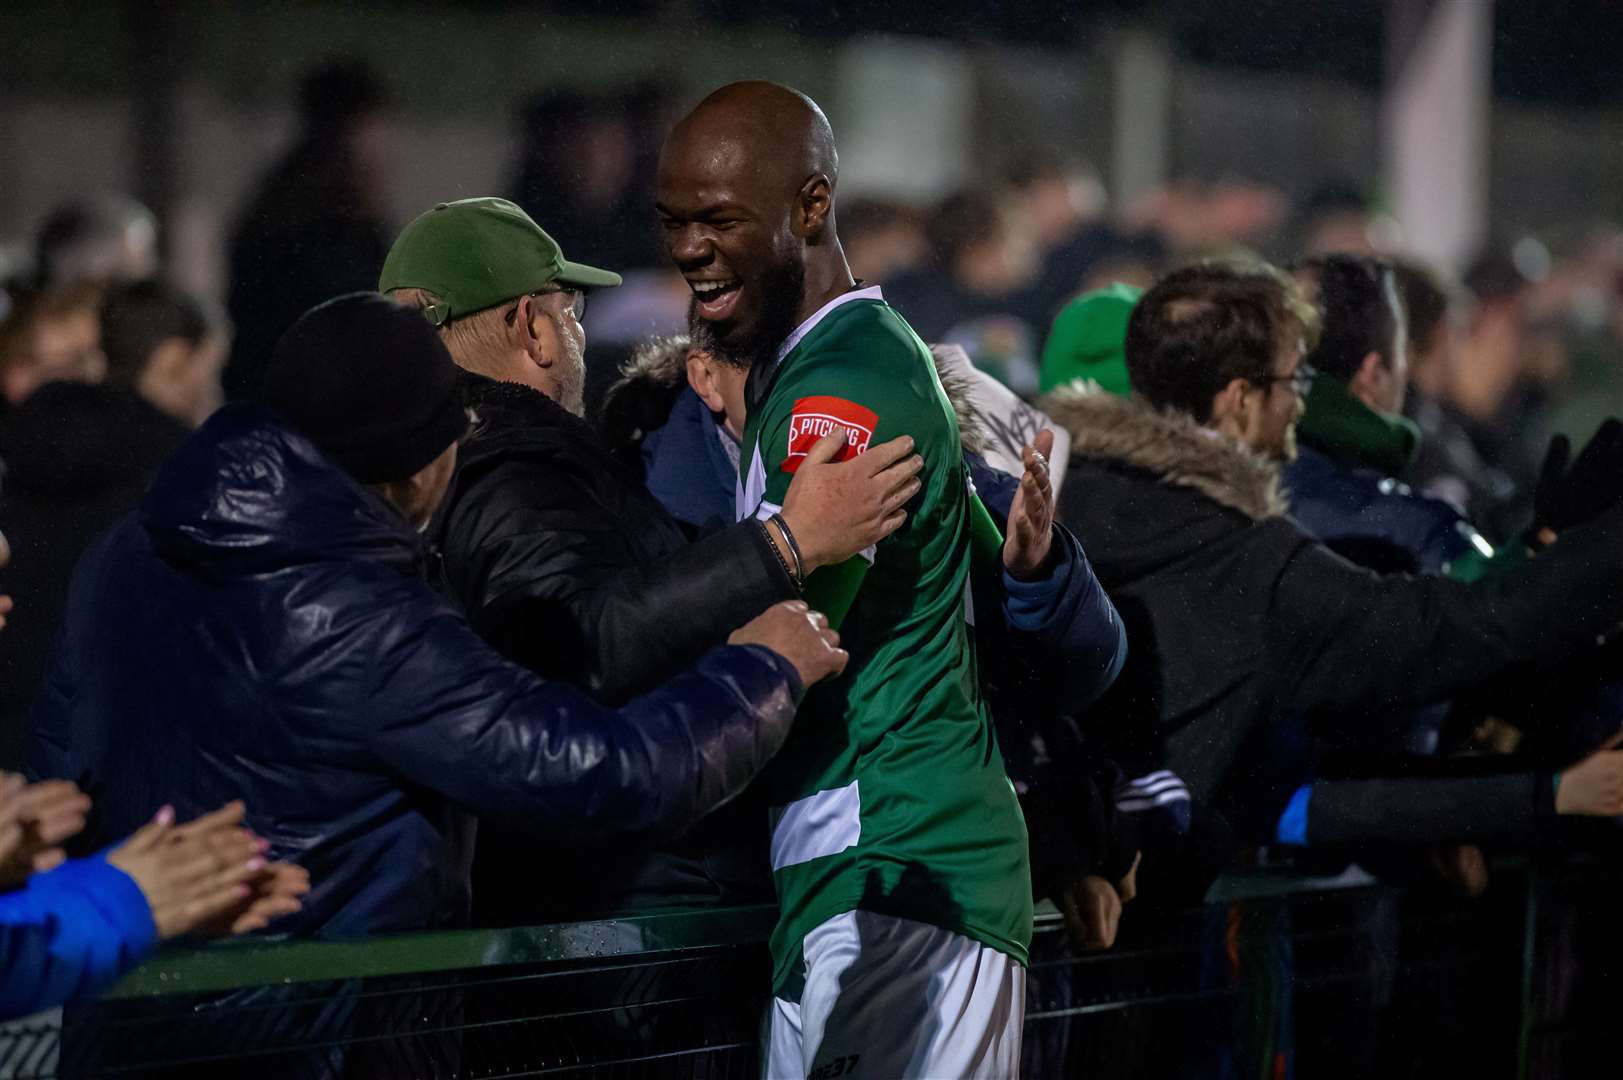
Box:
0;65;1623;1078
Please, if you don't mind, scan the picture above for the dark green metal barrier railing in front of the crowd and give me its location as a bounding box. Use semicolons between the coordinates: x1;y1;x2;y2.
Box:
0;869;1623;1080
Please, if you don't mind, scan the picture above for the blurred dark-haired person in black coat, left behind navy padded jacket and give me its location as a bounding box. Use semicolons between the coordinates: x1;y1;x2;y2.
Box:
0;281;226;770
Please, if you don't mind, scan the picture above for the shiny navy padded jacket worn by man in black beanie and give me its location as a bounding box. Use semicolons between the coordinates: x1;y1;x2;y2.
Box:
29;406;800;935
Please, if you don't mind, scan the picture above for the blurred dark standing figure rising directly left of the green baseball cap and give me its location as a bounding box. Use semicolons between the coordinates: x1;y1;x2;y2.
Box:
224;60;391;398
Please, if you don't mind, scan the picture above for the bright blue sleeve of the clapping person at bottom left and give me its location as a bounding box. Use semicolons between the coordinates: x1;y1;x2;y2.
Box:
0;854;157;1020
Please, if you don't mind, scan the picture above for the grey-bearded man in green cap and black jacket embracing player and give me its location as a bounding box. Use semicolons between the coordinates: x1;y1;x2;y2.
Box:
378;198;920;922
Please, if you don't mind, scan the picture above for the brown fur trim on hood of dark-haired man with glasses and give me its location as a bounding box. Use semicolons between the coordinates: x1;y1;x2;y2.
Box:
1042;385;1289;521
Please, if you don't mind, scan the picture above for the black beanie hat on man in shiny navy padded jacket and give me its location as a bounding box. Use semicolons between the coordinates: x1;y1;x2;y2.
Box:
265;292;467;484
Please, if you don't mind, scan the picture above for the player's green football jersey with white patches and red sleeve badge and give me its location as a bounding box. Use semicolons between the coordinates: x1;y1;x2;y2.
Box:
738;289;1032;997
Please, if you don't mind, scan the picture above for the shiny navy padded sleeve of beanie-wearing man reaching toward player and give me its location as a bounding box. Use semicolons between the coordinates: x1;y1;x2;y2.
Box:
354;580;800;843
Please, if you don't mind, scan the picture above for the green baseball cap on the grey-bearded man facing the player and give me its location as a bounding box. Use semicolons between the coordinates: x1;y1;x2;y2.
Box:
378;197;620;326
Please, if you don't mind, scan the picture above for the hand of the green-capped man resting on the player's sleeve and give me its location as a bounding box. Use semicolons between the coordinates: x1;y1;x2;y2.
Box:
782;424;923;573
